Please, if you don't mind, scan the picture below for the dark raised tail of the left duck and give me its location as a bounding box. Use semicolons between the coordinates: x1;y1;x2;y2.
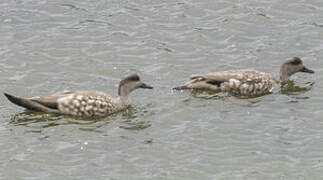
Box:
4;93;57;113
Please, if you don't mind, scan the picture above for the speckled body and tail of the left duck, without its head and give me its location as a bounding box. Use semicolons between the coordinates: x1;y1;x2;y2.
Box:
5;91;126;117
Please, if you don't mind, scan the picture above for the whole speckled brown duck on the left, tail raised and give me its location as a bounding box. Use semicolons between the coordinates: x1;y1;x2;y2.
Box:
4;74;153;117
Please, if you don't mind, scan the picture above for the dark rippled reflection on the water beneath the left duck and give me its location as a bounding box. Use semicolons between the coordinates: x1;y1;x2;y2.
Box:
10;106;152;132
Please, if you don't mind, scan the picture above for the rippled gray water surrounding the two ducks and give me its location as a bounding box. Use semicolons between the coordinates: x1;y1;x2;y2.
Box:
0;0;323;180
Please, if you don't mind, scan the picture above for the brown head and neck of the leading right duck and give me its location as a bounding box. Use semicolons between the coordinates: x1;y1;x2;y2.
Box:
279;57;314;82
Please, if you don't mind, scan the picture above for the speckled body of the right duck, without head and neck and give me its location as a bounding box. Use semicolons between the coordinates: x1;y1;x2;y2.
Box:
175;69;279;96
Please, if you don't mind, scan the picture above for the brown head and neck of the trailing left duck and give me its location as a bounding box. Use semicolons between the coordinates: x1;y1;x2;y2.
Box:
118;74;153;97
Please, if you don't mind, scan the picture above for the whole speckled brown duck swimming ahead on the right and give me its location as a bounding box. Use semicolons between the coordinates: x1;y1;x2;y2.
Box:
173;57;314;96
